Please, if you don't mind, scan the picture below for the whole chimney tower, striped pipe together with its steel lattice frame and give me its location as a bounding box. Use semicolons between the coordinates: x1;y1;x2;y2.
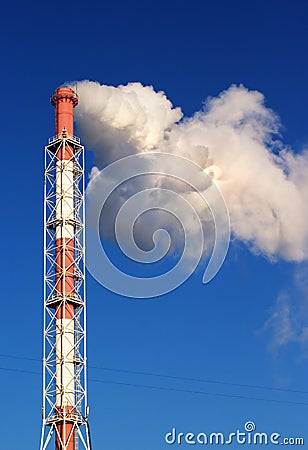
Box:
40;87;91;450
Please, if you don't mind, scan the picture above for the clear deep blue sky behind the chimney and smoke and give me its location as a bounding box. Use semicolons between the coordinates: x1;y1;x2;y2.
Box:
0;0;308;450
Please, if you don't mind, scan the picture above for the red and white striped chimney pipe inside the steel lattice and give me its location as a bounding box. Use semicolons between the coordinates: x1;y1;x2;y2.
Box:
51;87;78;450
